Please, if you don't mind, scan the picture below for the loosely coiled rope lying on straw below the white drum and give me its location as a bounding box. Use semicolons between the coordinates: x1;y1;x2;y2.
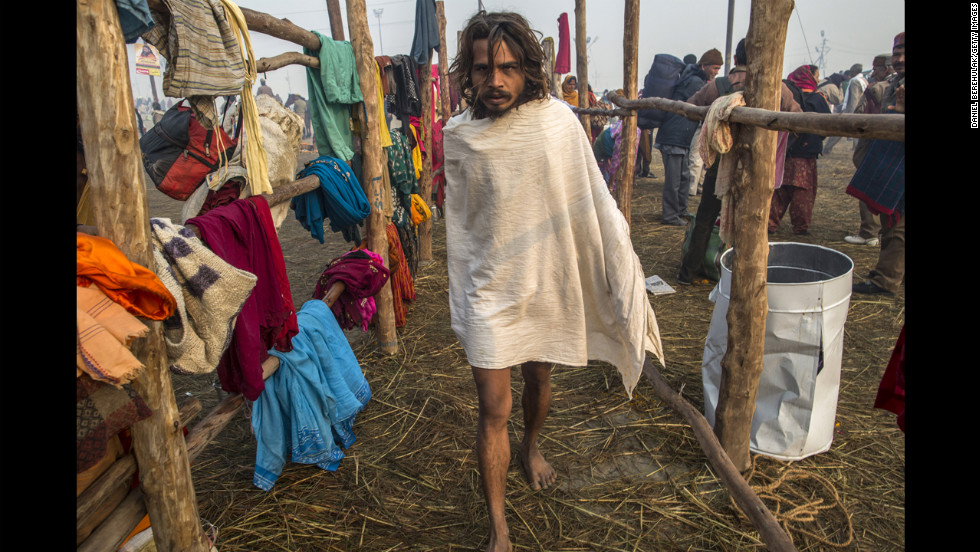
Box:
729;454;854;548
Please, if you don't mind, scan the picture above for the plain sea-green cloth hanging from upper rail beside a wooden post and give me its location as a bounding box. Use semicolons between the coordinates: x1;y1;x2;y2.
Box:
303;31;364;163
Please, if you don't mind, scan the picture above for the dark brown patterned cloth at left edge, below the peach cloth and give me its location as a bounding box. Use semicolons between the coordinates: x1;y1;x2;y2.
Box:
75;375;153;473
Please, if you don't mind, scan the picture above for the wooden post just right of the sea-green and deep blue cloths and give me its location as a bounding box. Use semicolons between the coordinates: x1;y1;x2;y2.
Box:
347;0;398;354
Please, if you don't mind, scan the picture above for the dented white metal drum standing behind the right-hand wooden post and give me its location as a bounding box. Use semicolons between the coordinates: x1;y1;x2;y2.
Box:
701;242;854;460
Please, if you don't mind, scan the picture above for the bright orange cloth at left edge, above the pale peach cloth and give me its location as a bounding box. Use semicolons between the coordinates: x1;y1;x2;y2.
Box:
75;232;177;320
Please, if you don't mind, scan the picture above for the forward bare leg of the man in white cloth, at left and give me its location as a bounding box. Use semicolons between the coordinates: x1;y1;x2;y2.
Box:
473;367;513;552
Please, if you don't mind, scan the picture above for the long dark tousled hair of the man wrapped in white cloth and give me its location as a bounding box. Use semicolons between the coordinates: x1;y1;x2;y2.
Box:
449;11;551;119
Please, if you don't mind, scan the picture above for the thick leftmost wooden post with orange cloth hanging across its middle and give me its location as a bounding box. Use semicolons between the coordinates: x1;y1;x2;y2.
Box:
75;0;208;552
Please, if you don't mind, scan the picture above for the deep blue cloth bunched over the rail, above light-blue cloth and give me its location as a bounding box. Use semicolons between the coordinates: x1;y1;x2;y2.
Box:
291;155;371;243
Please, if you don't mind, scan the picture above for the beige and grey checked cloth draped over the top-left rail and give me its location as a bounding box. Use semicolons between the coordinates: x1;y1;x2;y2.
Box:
142;0;246;129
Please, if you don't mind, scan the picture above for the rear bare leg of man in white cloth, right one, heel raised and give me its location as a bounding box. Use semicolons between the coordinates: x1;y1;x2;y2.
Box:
520;362;558;490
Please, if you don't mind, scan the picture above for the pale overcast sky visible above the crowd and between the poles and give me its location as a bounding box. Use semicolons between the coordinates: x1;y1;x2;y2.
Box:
127;0;905;100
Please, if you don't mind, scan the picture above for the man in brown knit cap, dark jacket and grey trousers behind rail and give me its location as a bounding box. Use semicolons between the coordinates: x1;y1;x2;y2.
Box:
654;48;724;226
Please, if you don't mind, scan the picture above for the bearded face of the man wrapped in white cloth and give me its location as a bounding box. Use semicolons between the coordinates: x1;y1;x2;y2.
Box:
470;38;524;117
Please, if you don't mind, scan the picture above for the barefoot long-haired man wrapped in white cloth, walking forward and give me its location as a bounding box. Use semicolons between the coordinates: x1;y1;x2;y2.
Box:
444;12;663;551
